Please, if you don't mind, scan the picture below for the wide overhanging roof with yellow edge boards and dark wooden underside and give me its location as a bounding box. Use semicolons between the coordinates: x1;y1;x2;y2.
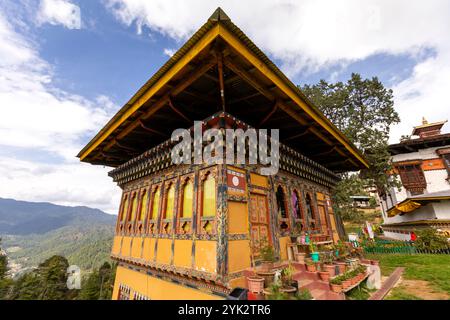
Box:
78;8;368;172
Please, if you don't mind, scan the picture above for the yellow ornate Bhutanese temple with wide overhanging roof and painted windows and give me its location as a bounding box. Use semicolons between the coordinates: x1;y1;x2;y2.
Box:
78;8;367;299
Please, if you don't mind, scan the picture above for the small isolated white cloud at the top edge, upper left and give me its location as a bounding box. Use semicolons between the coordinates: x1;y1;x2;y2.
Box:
37;0;81;29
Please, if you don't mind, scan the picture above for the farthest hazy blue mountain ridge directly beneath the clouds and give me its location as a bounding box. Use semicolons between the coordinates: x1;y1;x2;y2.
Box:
0;198;116;235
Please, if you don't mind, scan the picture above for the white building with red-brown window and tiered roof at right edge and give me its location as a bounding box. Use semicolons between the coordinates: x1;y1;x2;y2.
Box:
380;119;450;240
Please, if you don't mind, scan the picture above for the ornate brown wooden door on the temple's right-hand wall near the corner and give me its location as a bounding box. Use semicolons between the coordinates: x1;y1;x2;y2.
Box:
250;193;272;257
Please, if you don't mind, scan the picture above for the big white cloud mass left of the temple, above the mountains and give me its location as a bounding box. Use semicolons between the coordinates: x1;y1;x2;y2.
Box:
0;11;120;213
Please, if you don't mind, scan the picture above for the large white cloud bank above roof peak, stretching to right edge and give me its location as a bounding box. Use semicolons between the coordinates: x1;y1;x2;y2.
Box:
105;0;450;140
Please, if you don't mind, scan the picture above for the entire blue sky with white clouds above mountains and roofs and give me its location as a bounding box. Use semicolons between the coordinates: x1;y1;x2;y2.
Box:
0;0;450;213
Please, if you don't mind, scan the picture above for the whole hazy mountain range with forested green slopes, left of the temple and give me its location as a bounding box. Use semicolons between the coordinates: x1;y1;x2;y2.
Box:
0;198;117;274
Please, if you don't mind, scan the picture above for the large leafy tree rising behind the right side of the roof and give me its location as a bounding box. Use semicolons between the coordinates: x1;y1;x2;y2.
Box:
301;73;400;221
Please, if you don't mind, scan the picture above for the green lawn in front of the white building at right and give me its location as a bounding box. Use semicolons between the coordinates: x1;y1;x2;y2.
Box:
367;254;450;295
